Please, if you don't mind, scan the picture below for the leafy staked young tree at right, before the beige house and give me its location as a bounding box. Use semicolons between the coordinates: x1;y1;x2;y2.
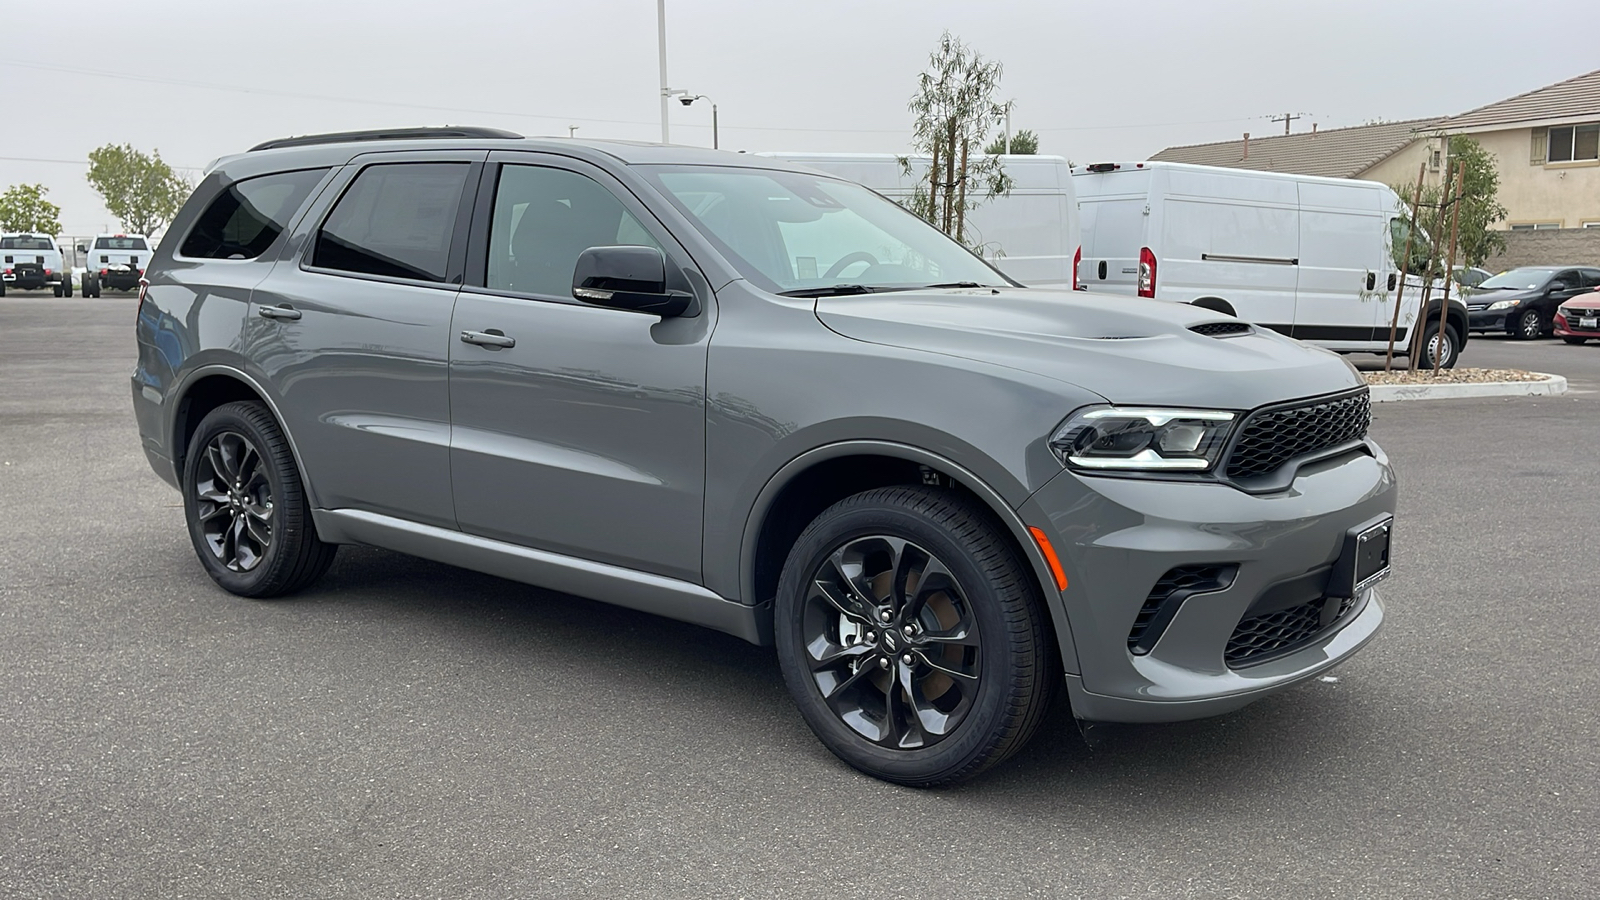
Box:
1394;135;1506;267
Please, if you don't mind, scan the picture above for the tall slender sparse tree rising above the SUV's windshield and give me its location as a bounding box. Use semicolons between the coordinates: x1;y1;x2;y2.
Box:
899;32;1011;243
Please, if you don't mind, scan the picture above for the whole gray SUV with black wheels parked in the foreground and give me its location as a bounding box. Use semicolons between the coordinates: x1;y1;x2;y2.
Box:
133;128;1395;785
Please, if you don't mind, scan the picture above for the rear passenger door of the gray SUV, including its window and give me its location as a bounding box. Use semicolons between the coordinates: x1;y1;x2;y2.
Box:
243;151;488;528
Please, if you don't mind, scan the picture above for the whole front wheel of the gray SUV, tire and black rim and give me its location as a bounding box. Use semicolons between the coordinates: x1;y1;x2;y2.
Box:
774;487;1059;786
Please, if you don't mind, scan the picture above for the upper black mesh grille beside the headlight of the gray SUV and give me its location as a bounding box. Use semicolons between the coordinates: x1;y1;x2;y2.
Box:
1227;388;1373;479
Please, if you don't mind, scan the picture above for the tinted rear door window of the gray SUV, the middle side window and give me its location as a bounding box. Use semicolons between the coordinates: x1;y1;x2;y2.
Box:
312;162;470;282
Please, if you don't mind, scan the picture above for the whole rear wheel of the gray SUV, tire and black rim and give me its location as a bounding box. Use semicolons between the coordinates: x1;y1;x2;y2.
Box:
182;402;339;597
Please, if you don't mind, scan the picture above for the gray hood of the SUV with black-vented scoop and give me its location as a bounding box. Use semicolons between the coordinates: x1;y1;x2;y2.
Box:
816;288;1365;410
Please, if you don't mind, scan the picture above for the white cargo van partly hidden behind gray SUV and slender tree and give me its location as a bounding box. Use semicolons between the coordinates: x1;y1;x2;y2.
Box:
757;152;1078;287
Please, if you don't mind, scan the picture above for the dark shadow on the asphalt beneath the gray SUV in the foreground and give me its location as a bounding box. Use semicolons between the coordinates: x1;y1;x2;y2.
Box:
272;548;1370;810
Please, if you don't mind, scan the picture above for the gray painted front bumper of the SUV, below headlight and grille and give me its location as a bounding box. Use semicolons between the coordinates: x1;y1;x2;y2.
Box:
1022;442;1395;722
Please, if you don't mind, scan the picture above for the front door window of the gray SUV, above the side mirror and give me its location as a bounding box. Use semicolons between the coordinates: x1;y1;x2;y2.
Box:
486;165;661;298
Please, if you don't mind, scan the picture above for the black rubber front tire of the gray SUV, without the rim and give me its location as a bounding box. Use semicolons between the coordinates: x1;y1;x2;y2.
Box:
774;501;1019;783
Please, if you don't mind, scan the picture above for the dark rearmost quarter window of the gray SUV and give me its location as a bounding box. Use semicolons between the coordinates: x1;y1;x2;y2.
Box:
181;168;328;259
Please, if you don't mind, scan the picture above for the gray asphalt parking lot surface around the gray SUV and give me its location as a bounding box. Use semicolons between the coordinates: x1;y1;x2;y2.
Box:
0;295;1600;900
